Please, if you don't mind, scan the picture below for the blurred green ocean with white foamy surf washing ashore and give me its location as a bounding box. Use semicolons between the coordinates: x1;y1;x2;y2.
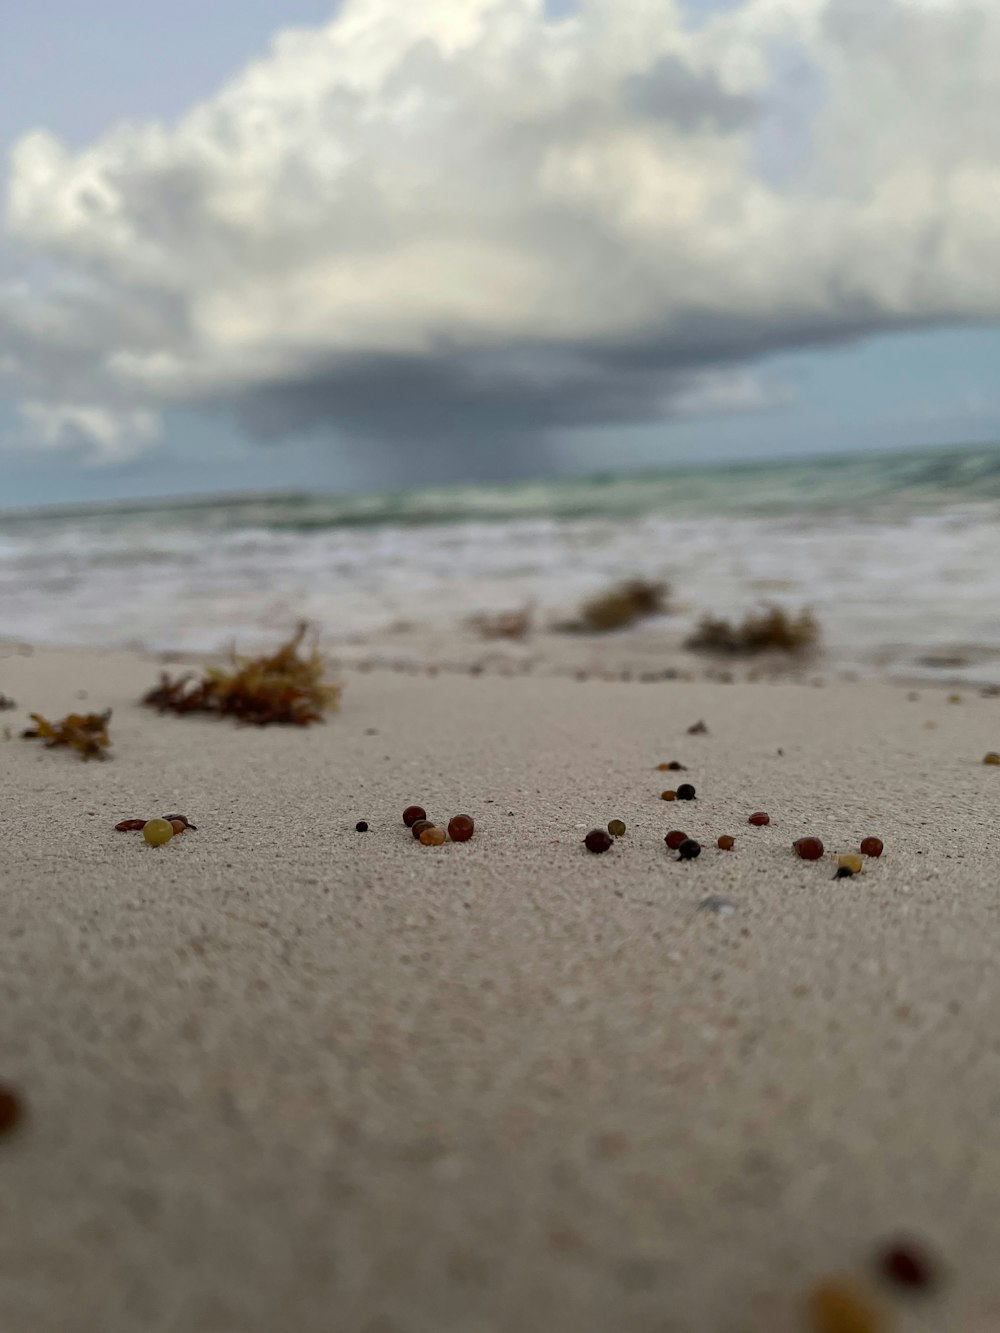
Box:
0;445;1000;684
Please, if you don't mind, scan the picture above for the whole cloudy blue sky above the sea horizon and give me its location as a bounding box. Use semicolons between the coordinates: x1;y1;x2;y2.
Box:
0;0;1000;507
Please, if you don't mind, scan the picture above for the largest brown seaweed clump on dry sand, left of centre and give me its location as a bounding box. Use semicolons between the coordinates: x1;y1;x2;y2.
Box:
143;624;341;726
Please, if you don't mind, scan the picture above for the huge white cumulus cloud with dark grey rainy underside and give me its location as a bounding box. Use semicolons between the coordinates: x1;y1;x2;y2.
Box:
0;0;1000;465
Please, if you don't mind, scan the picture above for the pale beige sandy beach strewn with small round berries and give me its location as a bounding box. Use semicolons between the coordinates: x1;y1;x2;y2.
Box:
0;647;1000;1333
